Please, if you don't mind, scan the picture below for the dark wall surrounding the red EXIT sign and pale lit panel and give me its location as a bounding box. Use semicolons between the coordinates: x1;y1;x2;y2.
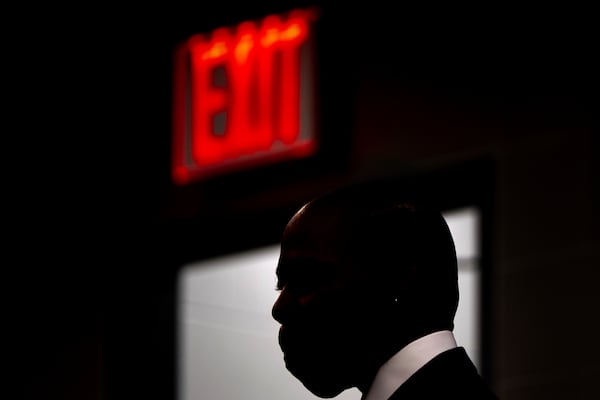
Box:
8;1;600;399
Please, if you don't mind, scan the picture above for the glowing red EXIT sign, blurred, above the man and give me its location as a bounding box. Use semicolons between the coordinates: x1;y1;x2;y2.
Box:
172;10;317;184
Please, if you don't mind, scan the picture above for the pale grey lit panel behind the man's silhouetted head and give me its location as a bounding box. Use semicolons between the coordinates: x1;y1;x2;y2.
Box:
178;208;480;400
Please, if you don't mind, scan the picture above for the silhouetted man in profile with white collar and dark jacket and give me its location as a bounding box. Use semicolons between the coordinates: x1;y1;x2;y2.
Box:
272;183;496;400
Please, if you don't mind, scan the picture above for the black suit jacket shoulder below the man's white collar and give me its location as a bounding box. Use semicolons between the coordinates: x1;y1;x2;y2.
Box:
389;347;498;400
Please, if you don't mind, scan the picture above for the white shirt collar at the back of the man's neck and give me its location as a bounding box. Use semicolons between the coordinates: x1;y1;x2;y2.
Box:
364;331;456;400
